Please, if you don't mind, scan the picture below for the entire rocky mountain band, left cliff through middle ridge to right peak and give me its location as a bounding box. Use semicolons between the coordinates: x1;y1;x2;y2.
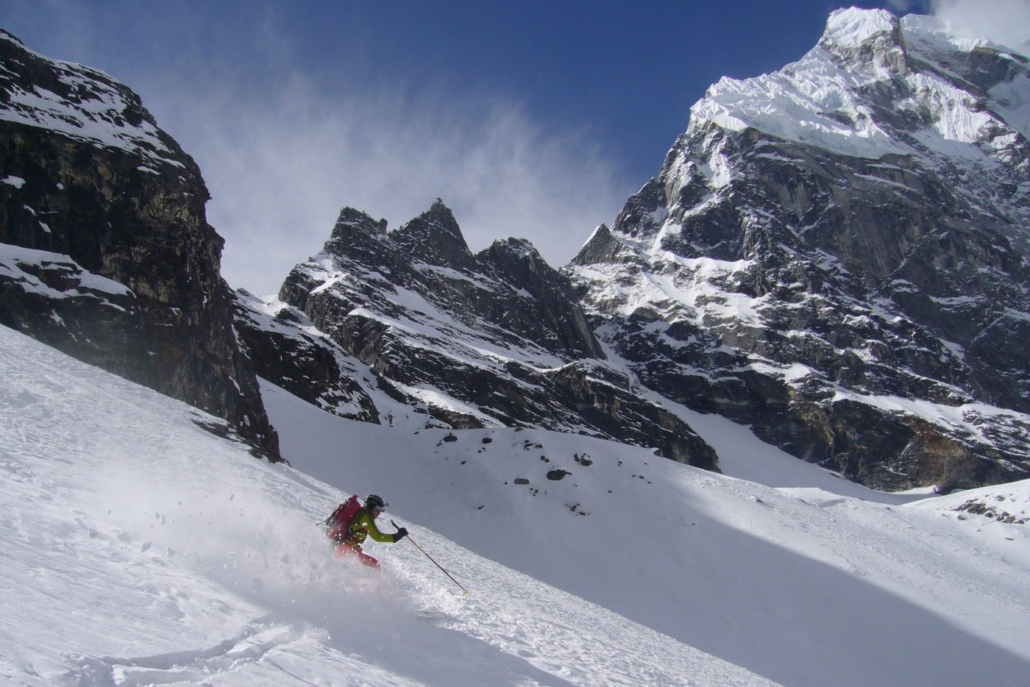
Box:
0;9;1030;491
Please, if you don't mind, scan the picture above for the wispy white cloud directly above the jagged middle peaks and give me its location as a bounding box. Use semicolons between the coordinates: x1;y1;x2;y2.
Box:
146;61;632;294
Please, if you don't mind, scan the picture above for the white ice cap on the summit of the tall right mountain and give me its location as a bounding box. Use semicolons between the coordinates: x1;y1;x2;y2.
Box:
687;8;1030;159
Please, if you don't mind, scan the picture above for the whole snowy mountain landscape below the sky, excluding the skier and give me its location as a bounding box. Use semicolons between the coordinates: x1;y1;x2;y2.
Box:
6;10;1030;687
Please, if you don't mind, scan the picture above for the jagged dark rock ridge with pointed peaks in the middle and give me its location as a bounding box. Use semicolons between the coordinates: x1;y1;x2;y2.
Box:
261;201;718;470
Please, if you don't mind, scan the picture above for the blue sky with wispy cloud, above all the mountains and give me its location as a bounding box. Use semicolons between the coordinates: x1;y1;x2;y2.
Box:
0;0;1013;294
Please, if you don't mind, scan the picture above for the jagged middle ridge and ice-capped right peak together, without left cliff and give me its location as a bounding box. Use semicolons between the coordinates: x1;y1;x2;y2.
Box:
238;9;1030;491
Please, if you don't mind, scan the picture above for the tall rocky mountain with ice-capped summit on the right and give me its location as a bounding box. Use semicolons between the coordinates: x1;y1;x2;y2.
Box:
565;9;1030;489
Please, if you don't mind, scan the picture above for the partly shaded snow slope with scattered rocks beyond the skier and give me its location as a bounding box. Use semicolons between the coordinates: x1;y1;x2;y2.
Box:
263;383;1030;686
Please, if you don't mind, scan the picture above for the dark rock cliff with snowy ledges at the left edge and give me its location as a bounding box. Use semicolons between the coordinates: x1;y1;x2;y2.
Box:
0;34;278;459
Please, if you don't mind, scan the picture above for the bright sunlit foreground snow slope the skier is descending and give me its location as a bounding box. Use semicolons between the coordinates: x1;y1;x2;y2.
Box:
0;328;773;687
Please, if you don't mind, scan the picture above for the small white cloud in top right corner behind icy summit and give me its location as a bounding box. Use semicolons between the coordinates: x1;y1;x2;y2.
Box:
933;0;1030;55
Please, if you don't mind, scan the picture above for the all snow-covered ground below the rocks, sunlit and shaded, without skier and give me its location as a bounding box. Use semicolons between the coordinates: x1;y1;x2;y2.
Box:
8;328;1030;687
